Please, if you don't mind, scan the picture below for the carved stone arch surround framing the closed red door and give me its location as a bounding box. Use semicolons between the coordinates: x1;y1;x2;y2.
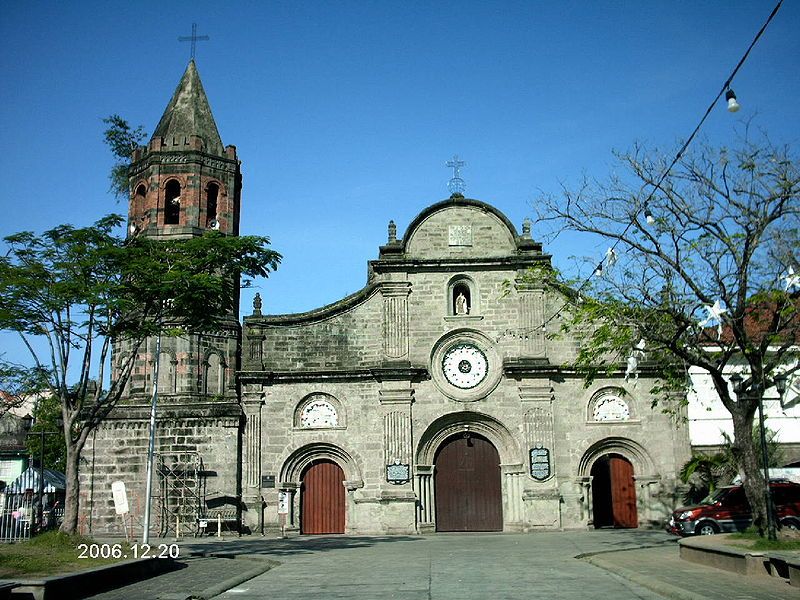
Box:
278;442;364;532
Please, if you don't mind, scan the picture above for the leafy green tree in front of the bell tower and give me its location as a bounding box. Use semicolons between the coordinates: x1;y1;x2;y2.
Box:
0;215;280;533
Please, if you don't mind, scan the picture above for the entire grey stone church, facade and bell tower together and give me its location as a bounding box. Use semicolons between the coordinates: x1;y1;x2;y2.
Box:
82;63;689;534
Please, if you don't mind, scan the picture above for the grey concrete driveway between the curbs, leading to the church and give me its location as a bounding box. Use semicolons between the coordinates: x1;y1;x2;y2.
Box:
212;532;664;600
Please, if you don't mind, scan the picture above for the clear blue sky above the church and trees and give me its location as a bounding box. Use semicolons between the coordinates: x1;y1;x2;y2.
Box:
0;0;800;328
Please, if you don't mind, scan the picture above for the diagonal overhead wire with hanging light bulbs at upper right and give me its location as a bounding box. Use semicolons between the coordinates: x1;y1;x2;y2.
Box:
541;0;783;338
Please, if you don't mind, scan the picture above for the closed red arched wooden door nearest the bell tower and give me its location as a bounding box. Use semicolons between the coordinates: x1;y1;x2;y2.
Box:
300;460;344;534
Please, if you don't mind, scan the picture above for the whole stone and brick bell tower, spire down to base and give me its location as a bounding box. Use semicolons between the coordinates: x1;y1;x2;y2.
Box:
81;60;242;535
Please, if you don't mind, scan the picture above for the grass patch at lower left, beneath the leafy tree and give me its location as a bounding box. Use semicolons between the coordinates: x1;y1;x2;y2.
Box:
0;531;127;578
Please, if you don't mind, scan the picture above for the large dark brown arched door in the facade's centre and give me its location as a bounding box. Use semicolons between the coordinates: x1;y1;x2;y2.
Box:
434;435;503;531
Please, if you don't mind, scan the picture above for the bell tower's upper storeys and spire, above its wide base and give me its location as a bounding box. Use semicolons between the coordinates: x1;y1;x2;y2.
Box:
128;60;242;404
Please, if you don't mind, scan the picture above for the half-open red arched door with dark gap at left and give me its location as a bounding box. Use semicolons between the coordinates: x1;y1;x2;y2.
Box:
592;454;639;528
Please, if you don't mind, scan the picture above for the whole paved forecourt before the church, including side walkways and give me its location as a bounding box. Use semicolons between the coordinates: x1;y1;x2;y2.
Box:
79;530;800;600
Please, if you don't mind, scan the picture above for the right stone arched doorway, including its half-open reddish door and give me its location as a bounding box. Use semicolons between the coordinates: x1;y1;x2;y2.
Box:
579;437;654;527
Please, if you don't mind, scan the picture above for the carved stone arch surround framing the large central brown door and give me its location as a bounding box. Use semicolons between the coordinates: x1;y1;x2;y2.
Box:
414;411;525;531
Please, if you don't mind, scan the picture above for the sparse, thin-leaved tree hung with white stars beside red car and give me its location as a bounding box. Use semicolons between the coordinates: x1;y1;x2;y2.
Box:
538;139;800;533
